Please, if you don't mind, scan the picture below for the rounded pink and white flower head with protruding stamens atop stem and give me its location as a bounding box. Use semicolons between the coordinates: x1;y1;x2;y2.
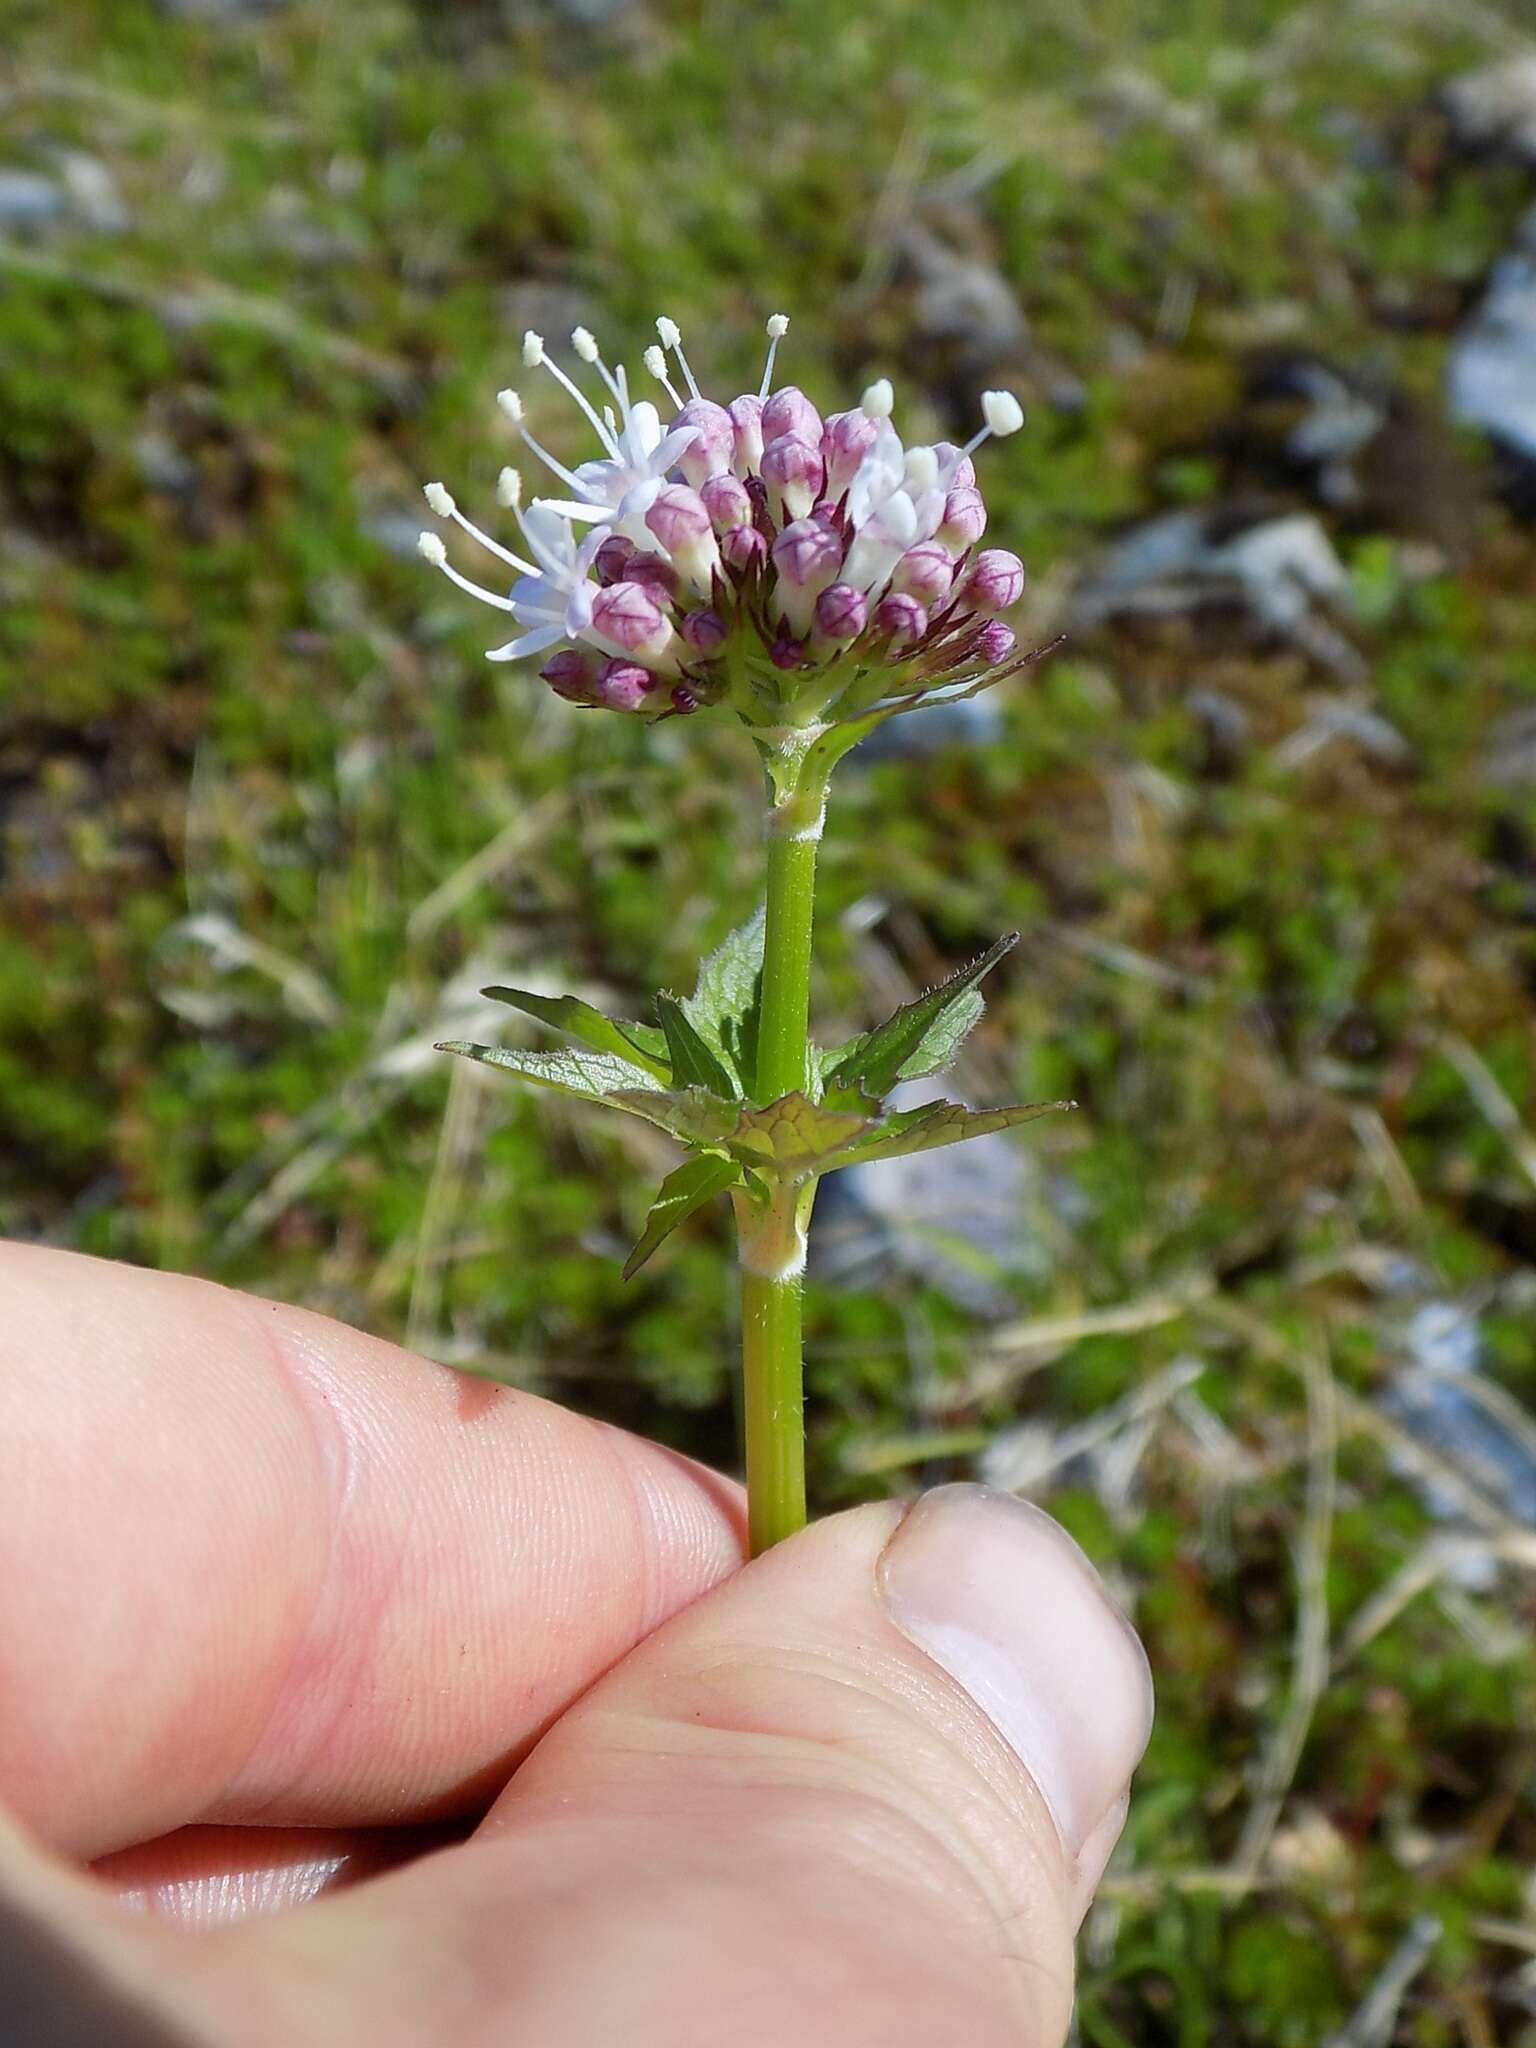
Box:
420;313;1024;723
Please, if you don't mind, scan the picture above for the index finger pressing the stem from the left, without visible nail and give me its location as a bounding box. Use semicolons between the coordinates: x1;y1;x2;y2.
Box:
0;1245;741;1858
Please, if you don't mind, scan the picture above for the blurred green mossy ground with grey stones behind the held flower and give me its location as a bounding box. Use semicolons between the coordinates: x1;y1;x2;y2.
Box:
0;0;1536;2048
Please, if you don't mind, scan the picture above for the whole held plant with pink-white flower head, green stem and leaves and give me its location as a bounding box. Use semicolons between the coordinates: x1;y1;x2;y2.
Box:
420;313;1059;1552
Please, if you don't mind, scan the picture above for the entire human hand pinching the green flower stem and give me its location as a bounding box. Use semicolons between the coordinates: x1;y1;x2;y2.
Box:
0;1247;1151;2048
